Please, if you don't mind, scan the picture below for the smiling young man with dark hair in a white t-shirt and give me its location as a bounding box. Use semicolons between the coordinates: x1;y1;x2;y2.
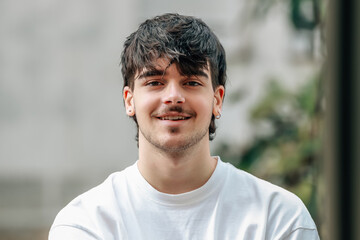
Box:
49;14;319;240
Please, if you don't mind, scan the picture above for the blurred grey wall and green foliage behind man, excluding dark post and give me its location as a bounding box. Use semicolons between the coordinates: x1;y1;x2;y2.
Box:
0;0;346;240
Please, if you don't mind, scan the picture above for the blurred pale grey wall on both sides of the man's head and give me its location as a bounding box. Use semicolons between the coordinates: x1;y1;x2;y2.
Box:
0;0;321;233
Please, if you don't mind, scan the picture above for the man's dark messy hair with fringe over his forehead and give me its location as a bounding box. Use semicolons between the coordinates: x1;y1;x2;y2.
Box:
121;13;226;141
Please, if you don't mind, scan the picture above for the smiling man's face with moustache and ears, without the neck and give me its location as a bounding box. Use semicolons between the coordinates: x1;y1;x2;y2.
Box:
124;59;224;152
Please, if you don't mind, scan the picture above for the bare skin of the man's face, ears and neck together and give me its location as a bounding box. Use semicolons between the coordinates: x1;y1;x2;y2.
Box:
123;58;224;194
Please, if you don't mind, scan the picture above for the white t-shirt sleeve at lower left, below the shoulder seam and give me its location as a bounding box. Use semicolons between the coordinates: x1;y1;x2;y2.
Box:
49;225;101;240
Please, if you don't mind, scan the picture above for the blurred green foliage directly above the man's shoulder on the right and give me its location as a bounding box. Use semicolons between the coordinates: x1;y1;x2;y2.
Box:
218;78;322;218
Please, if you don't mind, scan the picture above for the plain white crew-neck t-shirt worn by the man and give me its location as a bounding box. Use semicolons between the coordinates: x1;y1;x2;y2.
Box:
49;158;319;240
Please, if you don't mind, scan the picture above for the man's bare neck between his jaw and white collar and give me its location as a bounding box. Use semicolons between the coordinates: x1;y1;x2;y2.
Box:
138;135;217;194
